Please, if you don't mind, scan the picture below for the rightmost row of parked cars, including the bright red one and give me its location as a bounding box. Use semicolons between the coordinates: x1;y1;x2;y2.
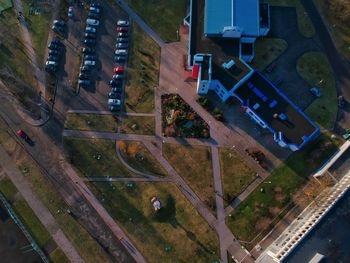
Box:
108;20;129;112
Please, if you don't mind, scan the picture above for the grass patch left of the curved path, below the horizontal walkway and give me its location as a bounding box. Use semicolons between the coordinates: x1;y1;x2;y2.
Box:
64;138;133;177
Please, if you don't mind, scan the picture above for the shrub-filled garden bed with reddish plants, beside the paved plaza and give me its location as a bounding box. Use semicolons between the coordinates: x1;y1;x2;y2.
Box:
162;94;210;138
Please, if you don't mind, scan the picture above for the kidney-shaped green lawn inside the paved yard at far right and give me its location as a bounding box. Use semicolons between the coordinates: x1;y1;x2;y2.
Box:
297;52;338;129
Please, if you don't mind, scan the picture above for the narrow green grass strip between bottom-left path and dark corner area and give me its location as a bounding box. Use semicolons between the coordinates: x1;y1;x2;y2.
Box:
12;200;51;247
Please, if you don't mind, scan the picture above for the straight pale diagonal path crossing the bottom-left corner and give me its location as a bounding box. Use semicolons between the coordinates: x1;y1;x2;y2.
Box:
0;146;84;262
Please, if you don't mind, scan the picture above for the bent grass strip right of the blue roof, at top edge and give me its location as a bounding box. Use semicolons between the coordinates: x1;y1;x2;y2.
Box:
270;0;316;38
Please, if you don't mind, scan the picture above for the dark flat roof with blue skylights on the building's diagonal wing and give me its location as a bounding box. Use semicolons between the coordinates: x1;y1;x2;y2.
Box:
234;71;318;146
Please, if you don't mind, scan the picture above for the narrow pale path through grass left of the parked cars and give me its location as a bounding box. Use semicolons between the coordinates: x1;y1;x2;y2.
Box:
13;0;46;98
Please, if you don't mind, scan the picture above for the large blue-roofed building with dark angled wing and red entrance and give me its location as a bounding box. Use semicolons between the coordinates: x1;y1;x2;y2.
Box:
184;0;319;151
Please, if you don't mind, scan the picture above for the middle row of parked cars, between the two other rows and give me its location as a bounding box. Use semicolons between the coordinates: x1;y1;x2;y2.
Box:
78;3;101;87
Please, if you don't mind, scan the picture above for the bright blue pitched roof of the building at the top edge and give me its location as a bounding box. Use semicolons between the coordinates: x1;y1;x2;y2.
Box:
204;0;260;37
